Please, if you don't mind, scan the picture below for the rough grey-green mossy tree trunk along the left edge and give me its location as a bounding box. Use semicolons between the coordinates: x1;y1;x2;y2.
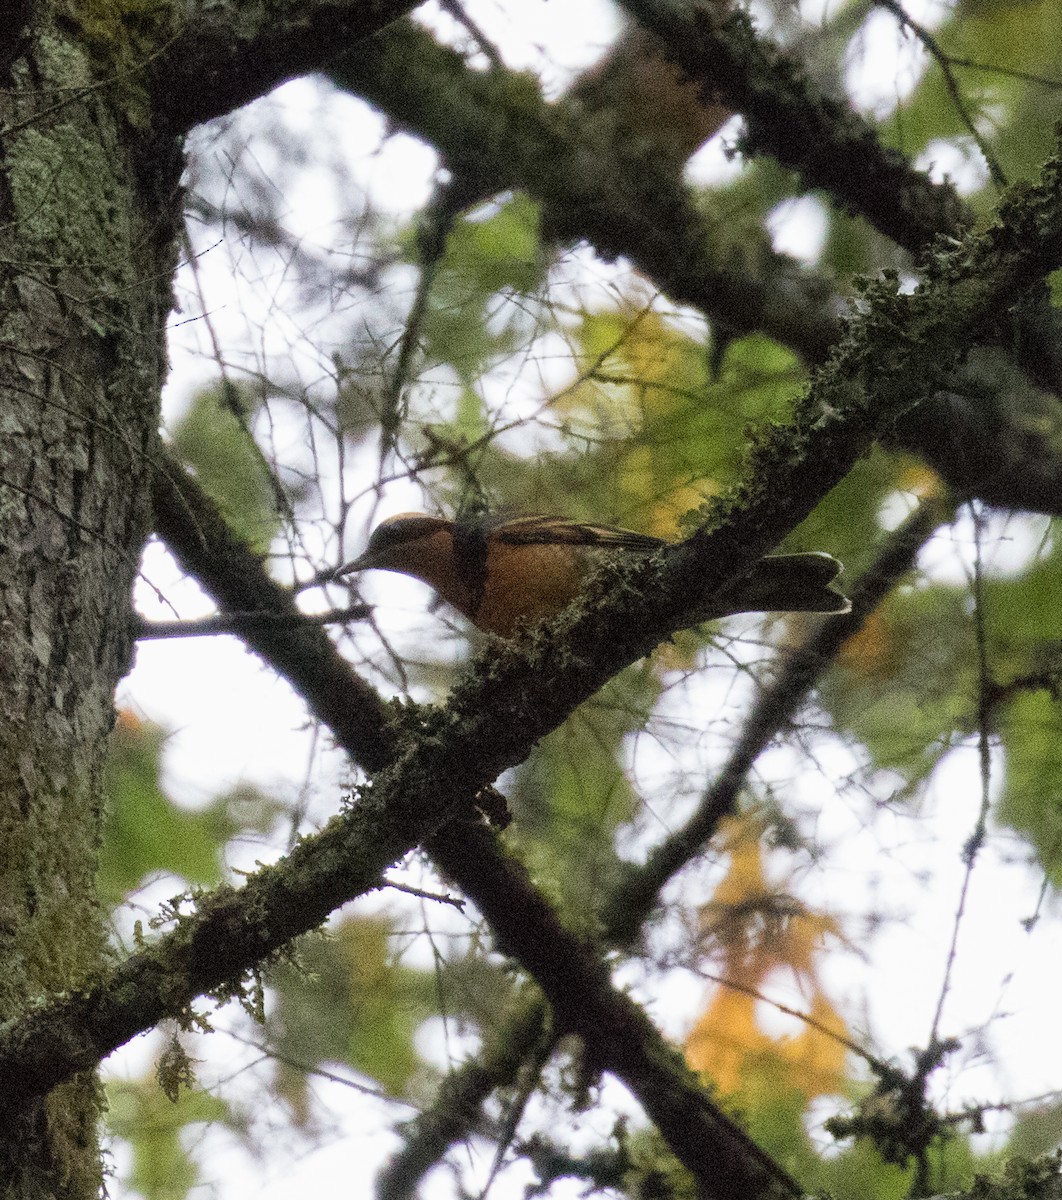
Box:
0;14;180;1200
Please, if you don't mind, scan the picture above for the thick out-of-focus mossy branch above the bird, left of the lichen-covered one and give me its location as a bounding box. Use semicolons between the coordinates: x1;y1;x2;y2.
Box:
329;22;840;362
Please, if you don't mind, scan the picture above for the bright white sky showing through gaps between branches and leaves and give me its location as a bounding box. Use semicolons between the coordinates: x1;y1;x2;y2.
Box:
112;0;1062;1200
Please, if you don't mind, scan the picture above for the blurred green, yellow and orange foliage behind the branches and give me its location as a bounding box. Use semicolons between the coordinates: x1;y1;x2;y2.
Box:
102;0;1062;1200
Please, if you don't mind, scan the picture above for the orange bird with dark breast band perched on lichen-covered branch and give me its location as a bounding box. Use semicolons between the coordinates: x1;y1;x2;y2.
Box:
332;512;851;638
